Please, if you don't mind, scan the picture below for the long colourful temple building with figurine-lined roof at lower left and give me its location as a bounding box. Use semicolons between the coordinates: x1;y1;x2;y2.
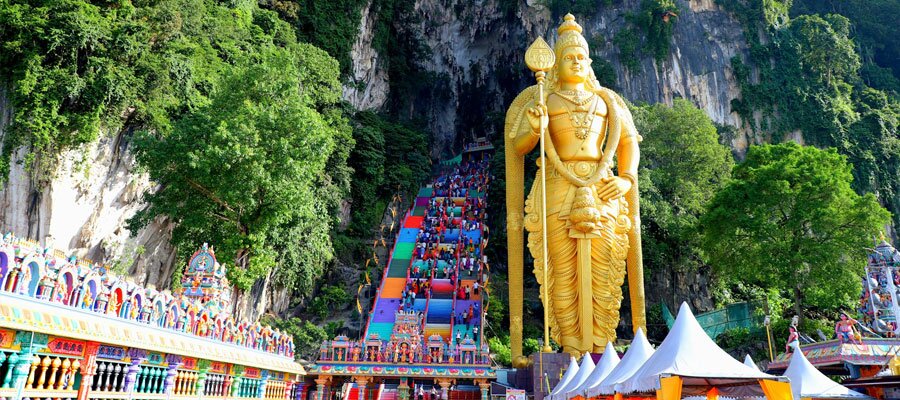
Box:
0;234;305;400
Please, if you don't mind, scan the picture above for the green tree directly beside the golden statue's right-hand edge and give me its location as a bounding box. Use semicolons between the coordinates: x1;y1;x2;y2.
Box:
633;99;734;278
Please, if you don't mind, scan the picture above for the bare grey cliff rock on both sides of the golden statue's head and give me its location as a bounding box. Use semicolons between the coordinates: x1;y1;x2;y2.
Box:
344;0;751;156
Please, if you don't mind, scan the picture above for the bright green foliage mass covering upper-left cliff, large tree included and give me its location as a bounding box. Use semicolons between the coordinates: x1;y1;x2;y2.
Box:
0;0;352;290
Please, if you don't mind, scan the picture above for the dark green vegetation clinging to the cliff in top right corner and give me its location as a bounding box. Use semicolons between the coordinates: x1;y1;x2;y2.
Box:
718;0;900;231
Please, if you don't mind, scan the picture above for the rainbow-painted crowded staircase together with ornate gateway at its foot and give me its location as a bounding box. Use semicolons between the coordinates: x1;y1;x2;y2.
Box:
309;145;496;400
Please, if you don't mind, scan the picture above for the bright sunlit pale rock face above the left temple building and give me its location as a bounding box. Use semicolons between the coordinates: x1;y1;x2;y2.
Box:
0;93;175;288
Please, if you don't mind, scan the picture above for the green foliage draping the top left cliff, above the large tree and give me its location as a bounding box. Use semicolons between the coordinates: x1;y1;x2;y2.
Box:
0;0;296;182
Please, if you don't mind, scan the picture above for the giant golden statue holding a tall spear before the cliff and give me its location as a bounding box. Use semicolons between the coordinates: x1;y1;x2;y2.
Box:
504;14;645;365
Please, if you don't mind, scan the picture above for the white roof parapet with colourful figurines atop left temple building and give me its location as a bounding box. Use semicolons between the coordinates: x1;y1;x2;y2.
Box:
0;234;302;373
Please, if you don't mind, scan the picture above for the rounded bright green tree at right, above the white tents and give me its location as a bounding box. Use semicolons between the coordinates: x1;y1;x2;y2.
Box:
701;143;890;317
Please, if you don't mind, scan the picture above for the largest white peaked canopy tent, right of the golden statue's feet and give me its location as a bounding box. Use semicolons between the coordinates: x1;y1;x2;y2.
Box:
616;303;777;397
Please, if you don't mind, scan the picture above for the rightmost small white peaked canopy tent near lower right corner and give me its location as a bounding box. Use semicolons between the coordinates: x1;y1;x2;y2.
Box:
784;345;872;400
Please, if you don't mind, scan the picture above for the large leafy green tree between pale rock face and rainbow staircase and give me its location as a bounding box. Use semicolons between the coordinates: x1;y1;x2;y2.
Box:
130;44;353;289
